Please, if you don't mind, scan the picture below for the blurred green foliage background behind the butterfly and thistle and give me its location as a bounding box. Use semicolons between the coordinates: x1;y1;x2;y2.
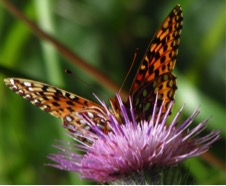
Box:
0;0;226;184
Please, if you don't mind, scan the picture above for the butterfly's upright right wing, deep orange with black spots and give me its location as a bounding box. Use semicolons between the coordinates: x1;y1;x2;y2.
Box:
129;5;183;119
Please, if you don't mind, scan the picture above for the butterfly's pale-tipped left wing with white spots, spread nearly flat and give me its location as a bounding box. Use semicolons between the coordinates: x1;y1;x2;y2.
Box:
4;78;106;134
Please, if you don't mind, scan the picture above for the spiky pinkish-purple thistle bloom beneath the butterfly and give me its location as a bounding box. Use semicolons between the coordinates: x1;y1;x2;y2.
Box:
49;95;220;183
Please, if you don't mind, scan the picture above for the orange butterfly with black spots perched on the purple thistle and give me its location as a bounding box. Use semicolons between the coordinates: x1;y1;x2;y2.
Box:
4;5;183;139
